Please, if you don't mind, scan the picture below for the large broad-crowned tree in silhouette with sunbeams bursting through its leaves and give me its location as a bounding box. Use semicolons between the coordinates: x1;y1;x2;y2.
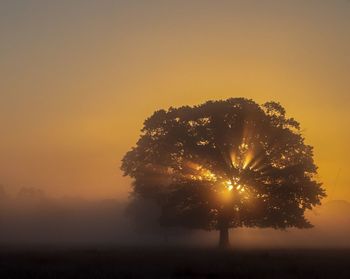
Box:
121;98;325;247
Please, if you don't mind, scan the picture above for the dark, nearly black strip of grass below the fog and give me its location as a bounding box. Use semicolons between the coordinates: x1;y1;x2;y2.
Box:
0;248;350;279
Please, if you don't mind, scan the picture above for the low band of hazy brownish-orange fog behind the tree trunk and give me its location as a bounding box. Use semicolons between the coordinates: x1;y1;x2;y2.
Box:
0;187;350;249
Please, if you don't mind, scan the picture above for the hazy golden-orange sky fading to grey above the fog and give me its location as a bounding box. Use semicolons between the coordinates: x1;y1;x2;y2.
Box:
0;0;350;201
